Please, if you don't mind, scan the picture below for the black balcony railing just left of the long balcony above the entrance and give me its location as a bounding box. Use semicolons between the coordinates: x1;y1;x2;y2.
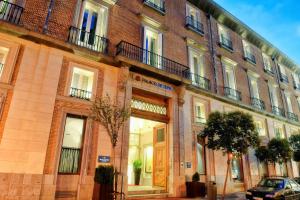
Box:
68;26;108;54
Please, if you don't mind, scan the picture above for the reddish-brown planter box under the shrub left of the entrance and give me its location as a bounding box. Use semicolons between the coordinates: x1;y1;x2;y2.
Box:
93;183;113;200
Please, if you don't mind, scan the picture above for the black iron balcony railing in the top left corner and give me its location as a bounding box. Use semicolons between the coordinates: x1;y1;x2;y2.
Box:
0;0;24;24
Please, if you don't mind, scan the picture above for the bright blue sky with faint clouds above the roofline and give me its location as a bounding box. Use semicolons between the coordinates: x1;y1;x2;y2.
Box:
215;0;300;64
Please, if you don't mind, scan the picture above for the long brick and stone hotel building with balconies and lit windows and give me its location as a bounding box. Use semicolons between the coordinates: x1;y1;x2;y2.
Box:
0;0;300;199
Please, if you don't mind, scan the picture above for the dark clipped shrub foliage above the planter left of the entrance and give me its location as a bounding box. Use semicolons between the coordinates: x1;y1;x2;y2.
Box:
94;165;114;185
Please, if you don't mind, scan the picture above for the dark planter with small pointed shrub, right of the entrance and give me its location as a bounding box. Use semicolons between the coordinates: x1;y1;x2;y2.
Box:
186;172;206;198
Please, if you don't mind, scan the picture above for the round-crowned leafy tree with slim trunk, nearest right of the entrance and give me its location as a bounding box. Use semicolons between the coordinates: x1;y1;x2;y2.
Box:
201;111;259;199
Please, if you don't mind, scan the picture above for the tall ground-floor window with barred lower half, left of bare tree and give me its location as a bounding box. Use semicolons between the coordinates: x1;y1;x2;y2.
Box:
58;115;85;174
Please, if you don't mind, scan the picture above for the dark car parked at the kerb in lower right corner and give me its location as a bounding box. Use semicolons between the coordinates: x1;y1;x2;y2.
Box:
246;177;300;200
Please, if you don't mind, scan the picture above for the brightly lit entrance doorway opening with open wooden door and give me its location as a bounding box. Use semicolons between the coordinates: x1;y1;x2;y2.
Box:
127;117;168;192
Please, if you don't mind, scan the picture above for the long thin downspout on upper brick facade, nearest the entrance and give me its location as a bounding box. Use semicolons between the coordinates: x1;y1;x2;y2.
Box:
206;14;219;94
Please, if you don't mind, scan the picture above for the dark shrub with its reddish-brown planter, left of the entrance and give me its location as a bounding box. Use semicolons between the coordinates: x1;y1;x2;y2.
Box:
93;165;114;200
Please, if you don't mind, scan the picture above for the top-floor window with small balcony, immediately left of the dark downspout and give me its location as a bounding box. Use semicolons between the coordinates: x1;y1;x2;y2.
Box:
186;3;204;34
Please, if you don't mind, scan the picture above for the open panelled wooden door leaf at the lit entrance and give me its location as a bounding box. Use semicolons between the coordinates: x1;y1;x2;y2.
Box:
153;125;168;187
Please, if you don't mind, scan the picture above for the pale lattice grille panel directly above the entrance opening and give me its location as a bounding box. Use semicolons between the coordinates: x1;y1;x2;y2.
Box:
131;99;167;115
